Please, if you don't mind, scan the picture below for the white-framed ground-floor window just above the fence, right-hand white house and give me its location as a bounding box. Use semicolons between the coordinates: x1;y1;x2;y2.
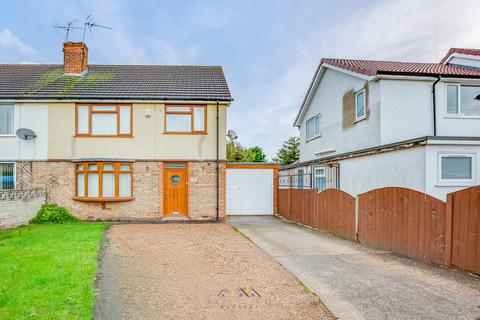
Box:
438;153;476;187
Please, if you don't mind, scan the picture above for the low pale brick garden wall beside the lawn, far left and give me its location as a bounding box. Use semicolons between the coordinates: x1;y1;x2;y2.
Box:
0;188;46;229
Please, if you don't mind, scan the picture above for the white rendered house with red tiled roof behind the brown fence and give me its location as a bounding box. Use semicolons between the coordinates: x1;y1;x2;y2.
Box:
281;48;480;200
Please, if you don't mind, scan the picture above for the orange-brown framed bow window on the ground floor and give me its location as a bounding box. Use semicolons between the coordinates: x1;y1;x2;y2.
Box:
73;161;135;207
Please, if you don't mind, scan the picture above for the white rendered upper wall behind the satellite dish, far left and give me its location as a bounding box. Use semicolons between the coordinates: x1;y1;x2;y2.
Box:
0;103;48;161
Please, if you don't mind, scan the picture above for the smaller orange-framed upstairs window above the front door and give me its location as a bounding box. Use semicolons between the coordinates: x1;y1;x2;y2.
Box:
165;105;207;134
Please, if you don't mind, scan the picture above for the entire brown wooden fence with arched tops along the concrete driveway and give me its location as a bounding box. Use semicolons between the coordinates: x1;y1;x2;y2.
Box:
279;186;480;274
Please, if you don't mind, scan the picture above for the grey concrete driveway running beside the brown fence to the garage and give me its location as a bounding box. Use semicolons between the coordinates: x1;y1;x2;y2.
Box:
228;217;480;320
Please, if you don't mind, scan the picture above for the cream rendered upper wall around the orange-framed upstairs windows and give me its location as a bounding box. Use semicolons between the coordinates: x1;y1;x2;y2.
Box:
48;103;227;160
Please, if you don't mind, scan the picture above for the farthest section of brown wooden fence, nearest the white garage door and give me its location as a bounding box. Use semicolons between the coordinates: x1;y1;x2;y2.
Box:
279;189;355;239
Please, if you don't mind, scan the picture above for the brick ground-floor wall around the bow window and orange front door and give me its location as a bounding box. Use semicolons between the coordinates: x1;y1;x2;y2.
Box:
27;161;225;220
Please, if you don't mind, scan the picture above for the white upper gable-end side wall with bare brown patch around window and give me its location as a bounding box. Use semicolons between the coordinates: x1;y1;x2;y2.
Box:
300;69;380;162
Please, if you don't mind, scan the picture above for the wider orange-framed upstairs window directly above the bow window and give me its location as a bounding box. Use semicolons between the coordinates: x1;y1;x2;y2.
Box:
75;103;133;138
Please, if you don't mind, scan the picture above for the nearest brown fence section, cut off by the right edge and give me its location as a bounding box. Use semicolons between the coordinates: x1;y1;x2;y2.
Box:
445;186;480;274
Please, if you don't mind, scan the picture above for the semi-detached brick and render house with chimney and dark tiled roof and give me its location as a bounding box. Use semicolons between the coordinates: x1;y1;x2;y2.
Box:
0;42;233;219
